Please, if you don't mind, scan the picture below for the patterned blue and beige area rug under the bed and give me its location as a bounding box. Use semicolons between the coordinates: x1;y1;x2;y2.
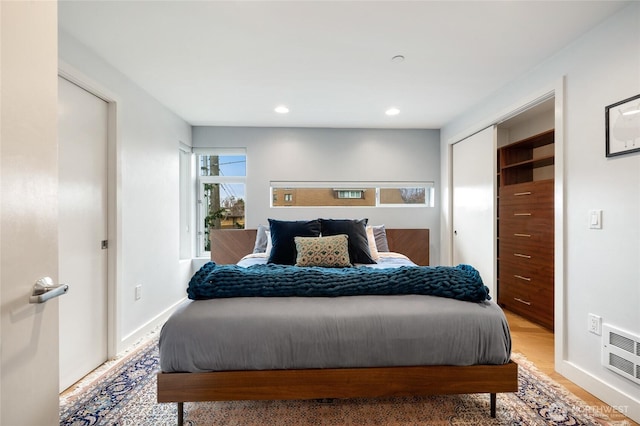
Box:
60;337;626;426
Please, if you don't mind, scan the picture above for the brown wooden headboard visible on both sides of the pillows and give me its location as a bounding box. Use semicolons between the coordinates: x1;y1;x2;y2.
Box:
209;229;429;266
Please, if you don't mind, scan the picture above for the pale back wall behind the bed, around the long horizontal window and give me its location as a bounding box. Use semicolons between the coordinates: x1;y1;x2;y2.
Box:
193;127;440;265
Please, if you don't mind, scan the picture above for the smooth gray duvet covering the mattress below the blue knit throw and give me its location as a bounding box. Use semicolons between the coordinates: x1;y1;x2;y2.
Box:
160;295;511;372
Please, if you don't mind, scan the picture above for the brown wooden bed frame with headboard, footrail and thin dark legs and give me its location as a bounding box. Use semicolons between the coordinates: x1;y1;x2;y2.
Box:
157;229;518;426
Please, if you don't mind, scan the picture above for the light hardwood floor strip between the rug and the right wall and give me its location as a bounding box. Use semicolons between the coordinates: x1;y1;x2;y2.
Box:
505;310;639;426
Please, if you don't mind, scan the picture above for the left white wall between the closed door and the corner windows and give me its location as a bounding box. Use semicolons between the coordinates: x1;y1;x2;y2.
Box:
59;31;191;352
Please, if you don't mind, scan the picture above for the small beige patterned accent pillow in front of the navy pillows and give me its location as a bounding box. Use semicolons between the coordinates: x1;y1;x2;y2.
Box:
295;234;351;268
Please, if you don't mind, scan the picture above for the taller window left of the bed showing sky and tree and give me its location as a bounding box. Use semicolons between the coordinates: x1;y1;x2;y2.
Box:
197;149;247;256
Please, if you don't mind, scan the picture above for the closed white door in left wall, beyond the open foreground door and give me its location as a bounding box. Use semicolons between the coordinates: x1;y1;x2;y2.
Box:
58;77;108;391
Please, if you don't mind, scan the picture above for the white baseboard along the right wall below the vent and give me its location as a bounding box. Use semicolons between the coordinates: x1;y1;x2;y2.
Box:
556;361;640;423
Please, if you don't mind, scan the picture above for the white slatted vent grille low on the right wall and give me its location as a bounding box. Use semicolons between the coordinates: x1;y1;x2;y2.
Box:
602;324;640;383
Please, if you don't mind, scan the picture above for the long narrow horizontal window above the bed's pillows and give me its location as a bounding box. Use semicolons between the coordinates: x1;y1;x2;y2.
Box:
271;182;434;207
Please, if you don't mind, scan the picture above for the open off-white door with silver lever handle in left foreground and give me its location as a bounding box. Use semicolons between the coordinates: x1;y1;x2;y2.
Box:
0;1;59;426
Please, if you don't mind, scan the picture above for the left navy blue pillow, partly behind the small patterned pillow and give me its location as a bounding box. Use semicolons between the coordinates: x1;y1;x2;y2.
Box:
267;219;320;265
